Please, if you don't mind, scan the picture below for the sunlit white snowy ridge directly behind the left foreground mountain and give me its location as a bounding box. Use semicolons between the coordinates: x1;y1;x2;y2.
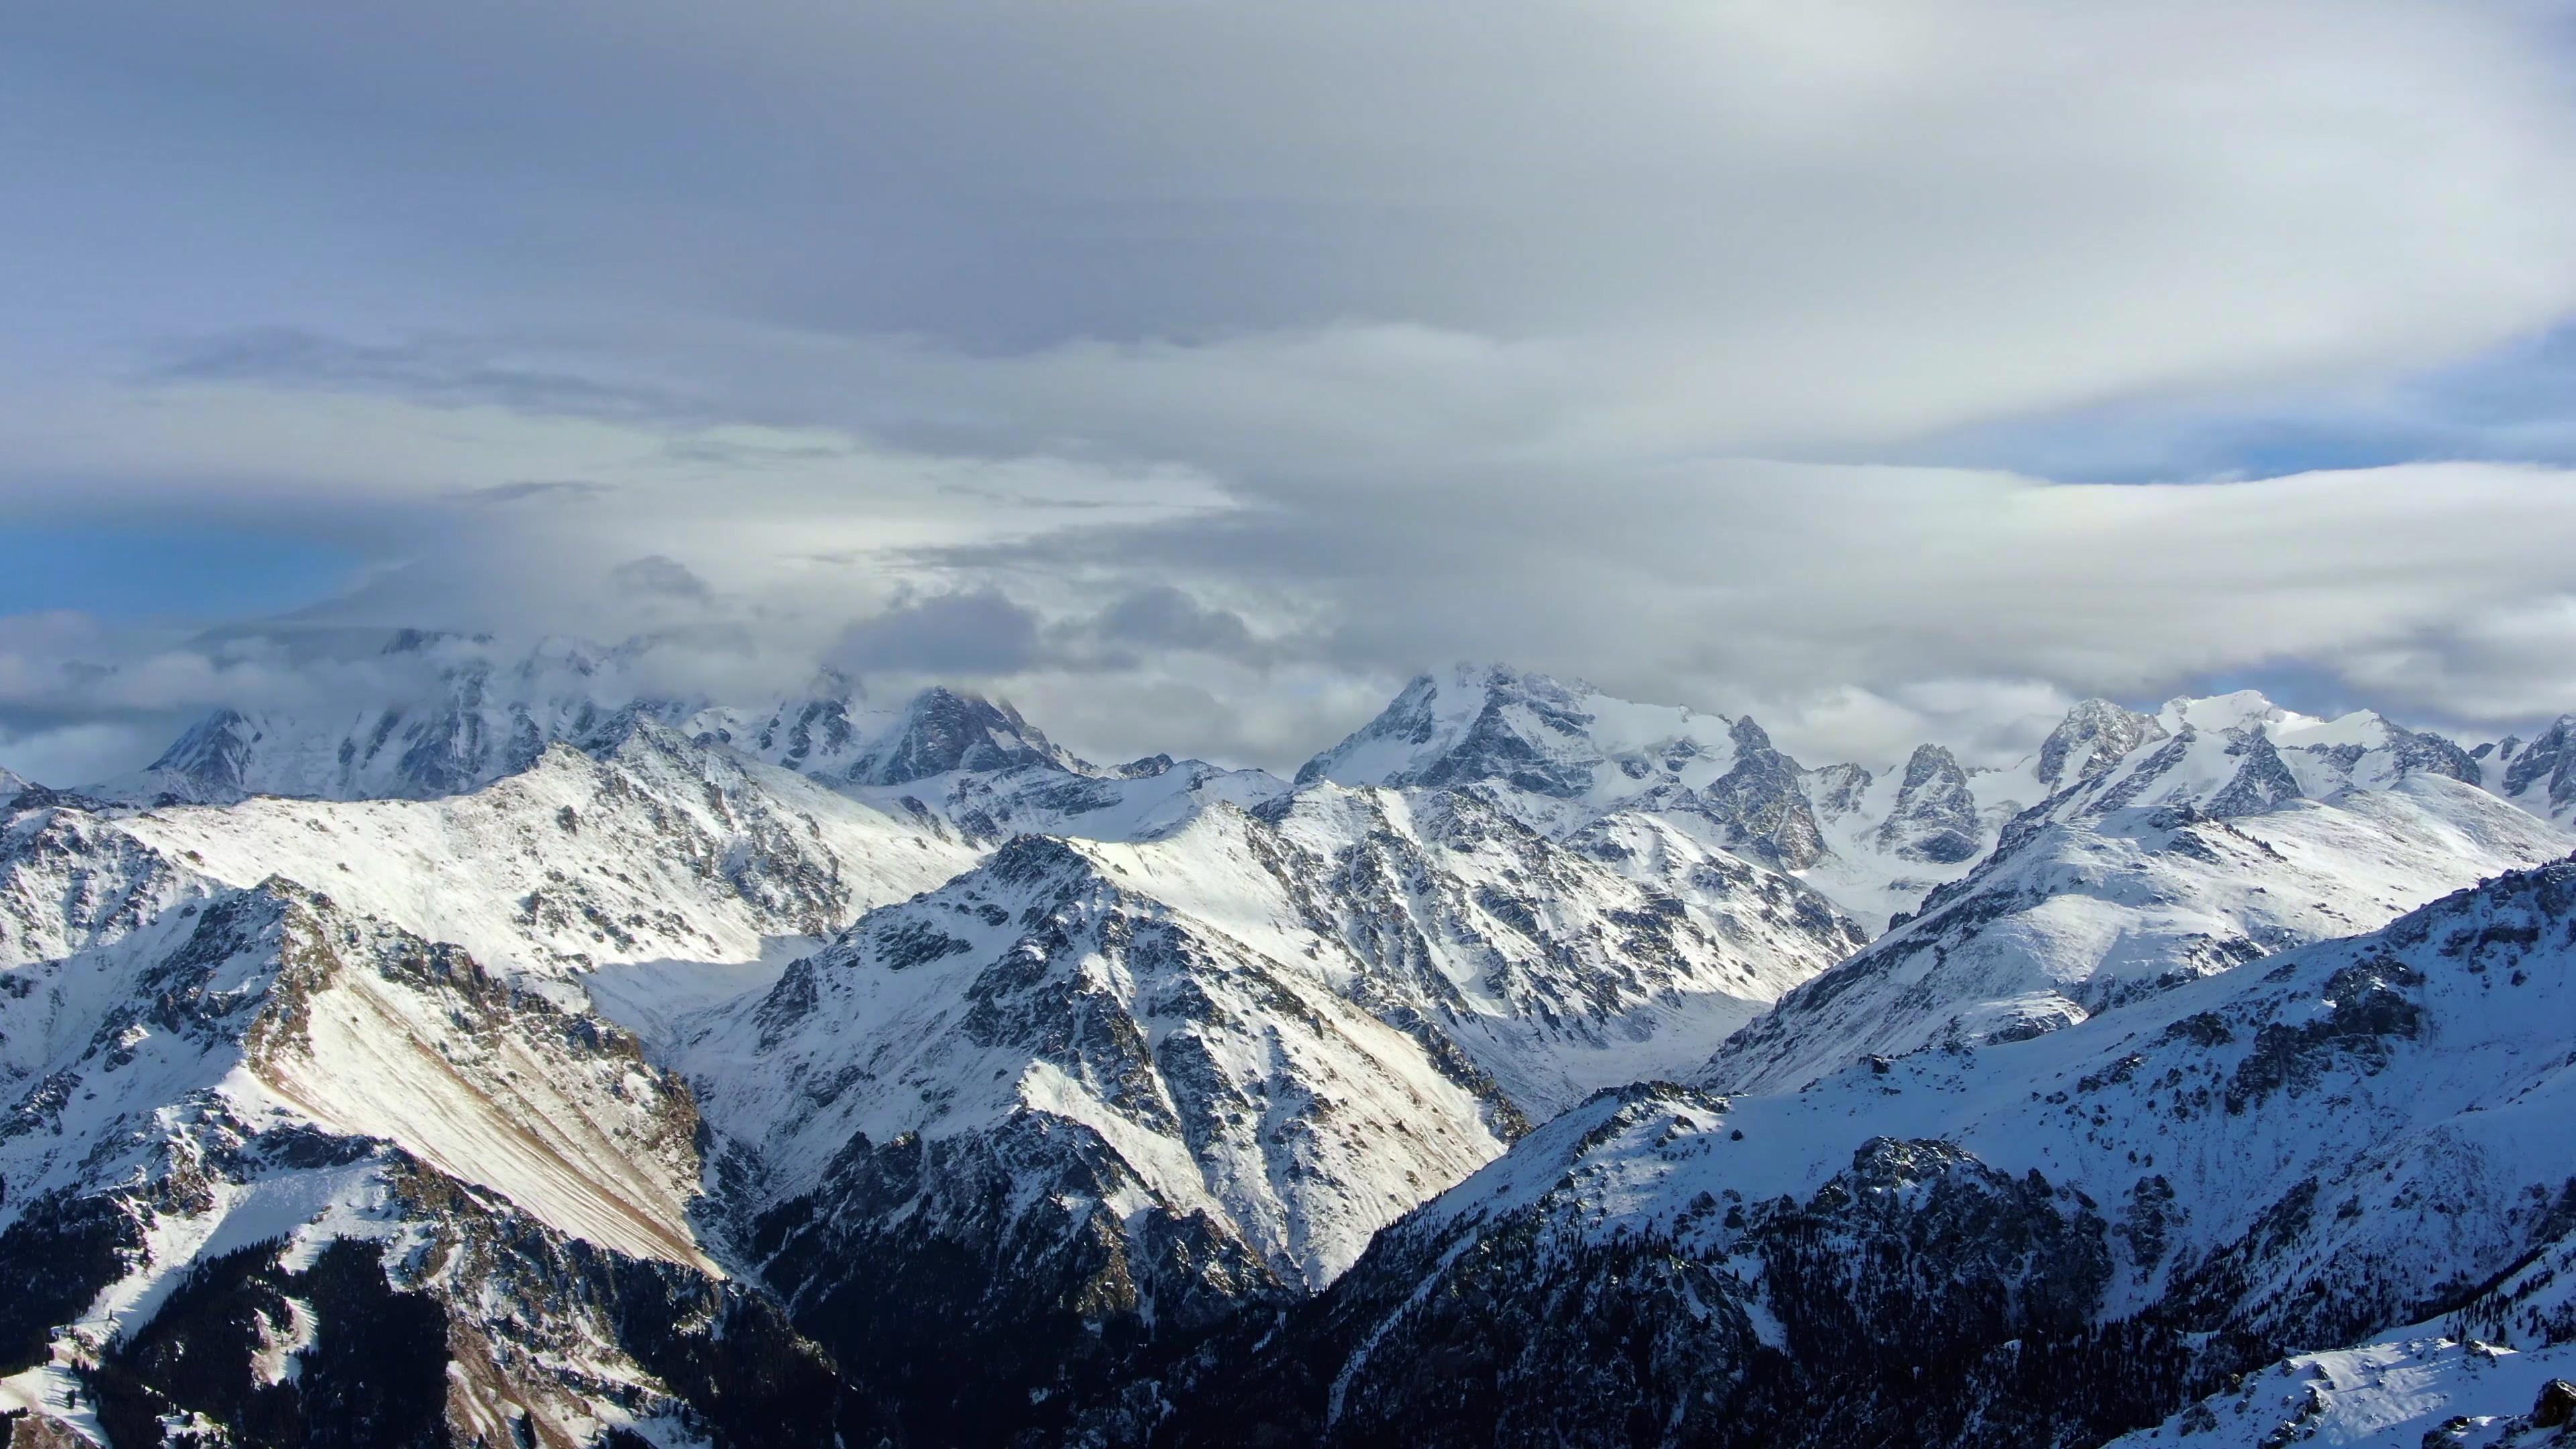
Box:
25;724;976;1000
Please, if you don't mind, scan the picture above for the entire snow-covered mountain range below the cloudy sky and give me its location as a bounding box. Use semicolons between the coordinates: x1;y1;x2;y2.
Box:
0;637;2576;1446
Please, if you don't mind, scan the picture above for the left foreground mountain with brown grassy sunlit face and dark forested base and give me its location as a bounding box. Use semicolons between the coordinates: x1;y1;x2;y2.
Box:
0;877;871;1444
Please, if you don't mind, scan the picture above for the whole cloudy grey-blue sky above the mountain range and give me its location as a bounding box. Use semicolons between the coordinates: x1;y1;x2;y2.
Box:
0;0;2576;782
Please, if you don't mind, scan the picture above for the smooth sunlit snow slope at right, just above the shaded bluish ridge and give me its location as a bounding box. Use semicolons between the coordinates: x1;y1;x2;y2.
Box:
1703;730;2576;1091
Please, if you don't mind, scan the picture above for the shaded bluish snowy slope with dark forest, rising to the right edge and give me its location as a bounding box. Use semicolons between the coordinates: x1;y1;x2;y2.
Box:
1148;864;2576;1446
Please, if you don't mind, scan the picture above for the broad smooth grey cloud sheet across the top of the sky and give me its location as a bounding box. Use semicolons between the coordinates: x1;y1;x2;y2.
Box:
15;0;2576;451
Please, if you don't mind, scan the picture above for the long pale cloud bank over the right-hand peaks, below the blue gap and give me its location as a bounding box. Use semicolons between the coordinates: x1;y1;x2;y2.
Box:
906;464;2576;758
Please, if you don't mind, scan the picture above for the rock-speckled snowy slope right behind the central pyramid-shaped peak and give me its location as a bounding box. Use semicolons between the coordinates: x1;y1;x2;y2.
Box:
1272;784;1865;1103
